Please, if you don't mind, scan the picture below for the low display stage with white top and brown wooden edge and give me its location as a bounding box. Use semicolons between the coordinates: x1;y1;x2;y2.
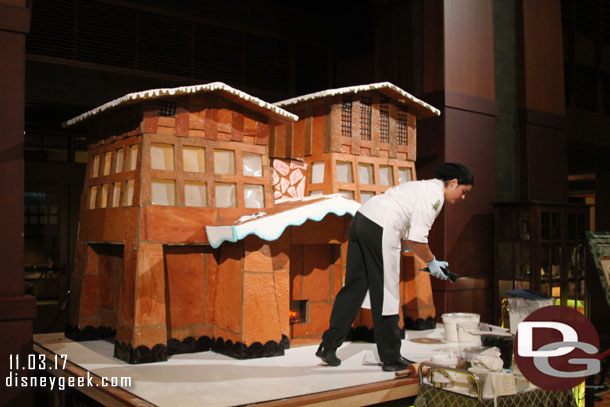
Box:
34;328;451;407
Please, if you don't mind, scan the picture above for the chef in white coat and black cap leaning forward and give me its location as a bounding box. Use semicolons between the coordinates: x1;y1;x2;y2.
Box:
316;163;474;371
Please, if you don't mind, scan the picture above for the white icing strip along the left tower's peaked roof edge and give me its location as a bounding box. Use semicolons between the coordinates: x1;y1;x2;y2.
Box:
62;82;299;127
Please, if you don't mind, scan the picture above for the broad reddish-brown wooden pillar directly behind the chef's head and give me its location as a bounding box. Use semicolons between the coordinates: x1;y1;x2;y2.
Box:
417;0;498;321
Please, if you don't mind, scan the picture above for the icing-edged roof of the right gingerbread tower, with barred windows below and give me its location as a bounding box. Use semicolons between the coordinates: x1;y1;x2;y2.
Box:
275;82;441;117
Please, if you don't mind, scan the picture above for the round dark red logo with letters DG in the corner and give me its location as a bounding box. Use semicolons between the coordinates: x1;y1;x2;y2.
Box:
514;305;600;390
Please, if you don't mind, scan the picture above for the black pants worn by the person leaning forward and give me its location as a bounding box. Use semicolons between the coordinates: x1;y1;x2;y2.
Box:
322;212;401;362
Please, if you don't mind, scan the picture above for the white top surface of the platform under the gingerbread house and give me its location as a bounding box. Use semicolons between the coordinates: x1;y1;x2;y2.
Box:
37;326;455;407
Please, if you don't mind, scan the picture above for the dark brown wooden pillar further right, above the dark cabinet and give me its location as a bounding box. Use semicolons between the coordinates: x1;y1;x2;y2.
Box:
517;0;568;203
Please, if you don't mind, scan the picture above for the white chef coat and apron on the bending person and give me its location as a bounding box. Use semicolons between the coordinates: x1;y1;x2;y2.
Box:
359;179;445;315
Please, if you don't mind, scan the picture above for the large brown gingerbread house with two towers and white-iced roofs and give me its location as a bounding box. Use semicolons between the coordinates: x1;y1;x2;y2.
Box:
64;82;438;363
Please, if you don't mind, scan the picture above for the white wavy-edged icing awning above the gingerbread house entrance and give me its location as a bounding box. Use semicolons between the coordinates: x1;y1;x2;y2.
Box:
205;195;360;249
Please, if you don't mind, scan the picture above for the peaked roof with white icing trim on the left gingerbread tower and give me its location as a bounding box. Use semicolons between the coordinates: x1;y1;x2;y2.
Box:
62;82;299;127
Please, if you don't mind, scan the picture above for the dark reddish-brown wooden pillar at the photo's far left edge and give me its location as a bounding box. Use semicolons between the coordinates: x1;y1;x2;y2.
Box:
0;0;36;405
